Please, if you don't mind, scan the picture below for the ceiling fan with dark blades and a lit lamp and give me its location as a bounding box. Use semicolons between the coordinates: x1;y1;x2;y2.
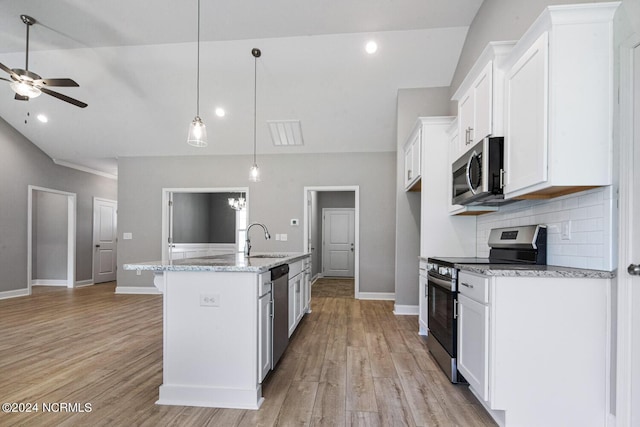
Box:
0;15;87;108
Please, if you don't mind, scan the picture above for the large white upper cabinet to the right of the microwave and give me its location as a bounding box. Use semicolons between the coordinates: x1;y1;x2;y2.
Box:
504;2;619;198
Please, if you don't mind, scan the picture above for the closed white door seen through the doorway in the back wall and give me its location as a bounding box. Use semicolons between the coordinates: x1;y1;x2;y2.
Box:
322;209;355;277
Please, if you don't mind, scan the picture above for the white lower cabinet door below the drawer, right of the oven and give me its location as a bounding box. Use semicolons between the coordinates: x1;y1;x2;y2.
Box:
458;294;489;401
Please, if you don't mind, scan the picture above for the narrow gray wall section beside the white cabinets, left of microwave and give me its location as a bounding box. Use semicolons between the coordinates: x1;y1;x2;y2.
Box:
395;87;451;305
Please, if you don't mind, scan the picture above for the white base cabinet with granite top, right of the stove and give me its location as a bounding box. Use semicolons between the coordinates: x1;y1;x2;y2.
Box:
458;266;612;427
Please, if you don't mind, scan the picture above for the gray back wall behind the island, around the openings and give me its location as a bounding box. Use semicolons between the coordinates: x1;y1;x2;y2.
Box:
118;152;396;292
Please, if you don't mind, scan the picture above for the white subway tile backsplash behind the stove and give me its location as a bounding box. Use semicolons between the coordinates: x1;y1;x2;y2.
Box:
476;186;617;271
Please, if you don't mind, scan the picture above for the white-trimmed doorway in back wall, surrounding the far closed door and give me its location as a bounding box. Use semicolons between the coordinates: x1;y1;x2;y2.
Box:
302;185;360;298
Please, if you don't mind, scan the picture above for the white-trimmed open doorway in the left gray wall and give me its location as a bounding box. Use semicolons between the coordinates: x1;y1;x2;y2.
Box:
27;185;76;295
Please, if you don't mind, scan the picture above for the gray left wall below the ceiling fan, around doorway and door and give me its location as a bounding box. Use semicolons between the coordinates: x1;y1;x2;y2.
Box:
0;118;117;292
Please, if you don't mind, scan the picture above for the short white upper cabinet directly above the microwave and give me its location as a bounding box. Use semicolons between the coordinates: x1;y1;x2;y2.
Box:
453;42;515;160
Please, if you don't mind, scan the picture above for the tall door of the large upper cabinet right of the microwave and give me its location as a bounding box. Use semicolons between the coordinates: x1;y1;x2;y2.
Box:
505;33;552;197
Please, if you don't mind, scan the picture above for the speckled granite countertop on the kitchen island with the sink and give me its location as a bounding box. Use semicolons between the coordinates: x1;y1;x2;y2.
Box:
123;252;311;273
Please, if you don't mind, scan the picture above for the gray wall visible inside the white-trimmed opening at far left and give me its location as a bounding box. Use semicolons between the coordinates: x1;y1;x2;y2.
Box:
31;191;68;280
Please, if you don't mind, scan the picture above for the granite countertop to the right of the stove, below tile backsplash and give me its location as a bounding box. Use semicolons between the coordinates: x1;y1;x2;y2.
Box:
456;264;616;279
